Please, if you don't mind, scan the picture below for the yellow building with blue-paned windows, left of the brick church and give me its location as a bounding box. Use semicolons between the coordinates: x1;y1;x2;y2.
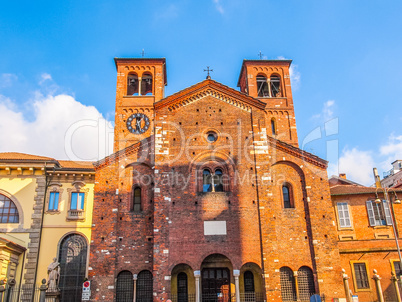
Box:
0;153;95;295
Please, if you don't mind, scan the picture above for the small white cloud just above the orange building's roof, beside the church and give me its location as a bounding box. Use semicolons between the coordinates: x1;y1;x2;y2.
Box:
336;148;375;186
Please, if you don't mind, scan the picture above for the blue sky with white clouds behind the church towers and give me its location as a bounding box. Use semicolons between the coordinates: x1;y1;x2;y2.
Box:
0;0;402;184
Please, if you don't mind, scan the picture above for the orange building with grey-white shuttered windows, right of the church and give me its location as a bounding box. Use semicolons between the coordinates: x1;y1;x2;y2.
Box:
329;174;402;301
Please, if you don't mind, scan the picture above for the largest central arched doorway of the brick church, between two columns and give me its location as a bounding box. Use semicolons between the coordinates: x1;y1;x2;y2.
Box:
201;254;234;302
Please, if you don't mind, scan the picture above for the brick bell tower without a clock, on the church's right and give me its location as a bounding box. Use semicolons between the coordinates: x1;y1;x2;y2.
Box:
237;60;298;147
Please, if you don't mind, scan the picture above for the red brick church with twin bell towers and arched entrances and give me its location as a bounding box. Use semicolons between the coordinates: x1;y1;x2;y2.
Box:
89;58;344;302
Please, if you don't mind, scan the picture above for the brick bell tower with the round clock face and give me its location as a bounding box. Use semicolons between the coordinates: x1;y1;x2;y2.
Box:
113;58;167;152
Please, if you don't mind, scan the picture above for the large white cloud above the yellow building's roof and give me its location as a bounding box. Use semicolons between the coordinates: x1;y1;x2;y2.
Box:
0;85;113;160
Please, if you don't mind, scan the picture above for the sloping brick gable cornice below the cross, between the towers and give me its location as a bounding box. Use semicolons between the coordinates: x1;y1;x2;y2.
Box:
154;79;266;110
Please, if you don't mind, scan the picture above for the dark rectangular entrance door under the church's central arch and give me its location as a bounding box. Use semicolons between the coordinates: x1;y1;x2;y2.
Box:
201;268;230;302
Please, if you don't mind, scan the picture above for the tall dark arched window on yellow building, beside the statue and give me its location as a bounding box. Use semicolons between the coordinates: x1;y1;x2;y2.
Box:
59;234;87;302
